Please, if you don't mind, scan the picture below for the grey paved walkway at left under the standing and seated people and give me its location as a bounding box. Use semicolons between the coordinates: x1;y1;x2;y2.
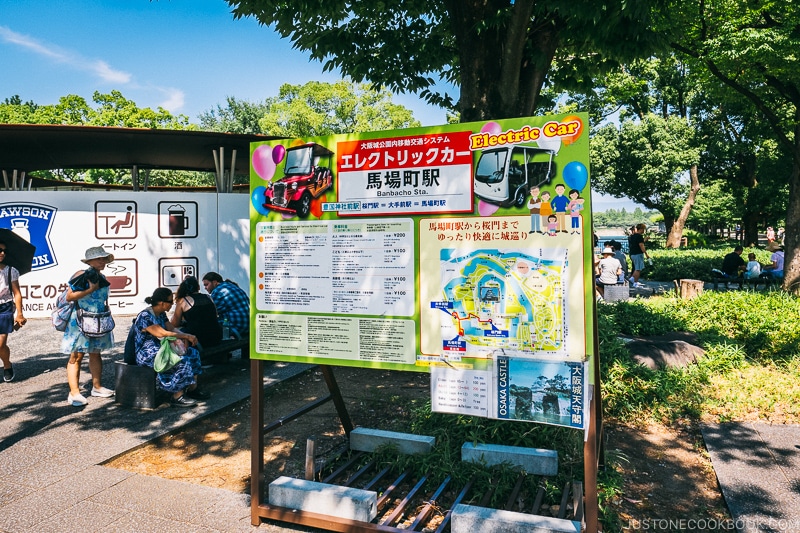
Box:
0;318;318;533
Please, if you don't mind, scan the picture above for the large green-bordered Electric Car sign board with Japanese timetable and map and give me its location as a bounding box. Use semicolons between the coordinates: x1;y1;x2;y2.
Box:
250;113;594;424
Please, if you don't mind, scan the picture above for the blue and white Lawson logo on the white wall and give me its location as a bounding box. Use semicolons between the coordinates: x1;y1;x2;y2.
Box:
0;203;58;271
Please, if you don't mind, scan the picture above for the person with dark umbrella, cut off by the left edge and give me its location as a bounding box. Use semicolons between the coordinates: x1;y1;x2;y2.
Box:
0;228;36;383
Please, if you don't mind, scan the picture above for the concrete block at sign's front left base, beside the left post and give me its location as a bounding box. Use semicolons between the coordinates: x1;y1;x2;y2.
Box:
269;476;378;522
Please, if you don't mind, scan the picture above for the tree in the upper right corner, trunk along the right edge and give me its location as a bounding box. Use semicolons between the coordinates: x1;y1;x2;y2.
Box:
672;0;800;291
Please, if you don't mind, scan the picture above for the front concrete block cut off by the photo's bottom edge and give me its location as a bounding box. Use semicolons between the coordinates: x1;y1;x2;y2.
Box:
450;503;581;533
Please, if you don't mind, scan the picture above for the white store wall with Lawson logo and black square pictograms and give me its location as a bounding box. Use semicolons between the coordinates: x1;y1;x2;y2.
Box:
0;191;250;318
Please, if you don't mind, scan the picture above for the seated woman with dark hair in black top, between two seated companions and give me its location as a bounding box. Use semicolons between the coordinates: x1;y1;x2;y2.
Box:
170;276;222;348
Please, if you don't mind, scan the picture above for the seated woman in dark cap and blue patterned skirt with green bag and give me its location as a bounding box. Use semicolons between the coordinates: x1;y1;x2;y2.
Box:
131;287;209;407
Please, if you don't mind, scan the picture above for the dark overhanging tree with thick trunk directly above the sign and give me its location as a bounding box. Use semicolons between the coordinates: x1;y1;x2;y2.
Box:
226;0;668;121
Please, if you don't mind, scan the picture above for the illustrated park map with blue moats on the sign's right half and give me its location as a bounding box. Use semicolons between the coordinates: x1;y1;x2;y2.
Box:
432;248;568;360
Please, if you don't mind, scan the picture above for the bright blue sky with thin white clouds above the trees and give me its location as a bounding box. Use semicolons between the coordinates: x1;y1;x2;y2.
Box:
0;0;633;211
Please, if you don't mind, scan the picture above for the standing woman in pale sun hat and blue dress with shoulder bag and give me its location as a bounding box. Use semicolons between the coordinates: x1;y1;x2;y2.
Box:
61;246;114;407
